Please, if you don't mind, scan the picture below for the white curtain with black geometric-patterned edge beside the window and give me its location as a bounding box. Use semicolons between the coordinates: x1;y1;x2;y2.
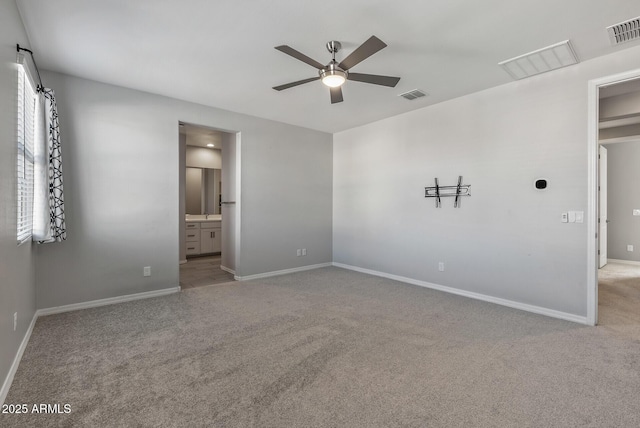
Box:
33;88;67;243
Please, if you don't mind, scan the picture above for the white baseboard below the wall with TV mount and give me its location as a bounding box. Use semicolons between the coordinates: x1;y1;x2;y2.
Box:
332;263;588;324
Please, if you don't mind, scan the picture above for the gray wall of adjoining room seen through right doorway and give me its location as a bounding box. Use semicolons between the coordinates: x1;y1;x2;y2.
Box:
605;142;640;262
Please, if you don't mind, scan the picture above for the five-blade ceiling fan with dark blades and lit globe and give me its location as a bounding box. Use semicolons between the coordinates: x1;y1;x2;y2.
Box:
273;36;400;104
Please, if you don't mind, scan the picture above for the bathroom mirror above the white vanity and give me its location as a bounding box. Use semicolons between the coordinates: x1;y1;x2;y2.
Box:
185;167;222;214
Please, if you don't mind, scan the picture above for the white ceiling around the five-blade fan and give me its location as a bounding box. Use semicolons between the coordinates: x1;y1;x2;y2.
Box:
16;0;640;132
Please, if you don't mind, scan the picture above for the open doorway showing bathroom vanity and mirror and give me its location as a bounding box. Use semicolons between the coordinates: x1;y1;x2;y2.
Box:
178;122;240;289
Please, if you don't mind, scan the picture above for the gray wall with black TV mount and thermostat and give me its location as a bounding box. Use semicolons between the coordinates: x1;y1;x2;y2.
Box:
333;47;640;316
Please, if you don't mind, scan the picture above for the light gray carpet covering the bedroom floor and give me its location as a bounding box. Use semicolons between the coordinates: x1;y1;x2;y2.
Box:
0;268;640;427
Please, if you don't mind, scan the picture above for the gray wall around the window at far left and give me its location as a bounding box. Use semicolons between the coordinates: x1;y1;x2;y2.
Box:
0;1;35;401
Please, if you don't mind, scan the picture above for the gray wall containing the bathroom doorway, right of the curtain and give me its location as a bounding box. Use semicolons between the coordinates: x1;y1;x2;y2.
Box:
37;72;332;308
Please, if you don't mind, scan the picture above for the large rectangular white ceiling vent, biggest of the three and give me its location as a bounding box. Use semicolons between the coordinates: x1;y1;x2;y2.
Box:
498;40;578;80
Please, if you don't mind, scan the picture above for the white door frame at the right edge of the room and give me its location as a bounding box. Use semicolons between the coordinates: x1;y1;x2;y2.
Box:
587;69;640;325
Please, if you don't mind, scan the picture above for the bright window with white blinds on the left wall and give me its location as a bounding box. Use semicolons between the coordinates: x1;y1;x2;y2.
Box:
17;62;36;244
